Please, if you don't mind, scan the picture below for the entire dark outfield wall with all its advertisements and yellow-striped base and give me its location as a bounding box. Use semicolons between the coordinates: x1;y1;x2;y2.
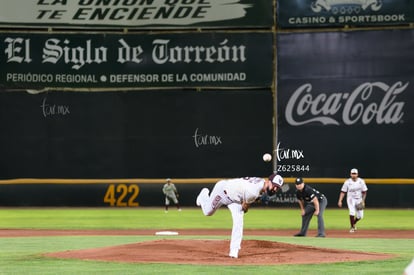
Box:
0;0;414;207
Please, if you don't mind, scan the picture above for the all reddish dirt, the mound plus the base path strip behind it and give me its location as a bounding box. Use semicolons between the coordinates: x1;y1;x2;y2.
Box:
0;229;414;265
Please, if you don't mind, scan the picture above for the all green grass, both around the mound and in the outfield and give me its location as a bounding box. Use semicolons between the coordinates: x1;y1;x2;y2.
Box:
0;208;414;274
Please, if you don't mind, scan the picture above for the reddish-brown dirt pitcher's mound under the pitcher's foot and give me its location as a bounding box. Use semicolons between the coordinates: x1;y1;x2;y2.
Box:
46;239;393;265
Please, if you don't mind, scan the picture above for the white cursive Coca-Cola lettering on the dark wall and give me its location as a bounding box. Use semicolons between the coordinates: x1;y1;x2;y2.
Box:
285;82;409;126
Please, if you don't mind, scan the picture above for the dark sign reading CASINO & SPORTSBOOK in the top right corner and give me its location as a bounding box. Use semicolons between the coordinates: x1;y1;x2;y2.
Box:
277;0;414;28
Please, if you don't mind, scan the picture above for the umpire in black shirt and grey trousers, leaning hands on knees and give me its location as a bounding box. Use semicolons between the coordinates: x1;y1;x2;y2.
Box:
294;178;328;237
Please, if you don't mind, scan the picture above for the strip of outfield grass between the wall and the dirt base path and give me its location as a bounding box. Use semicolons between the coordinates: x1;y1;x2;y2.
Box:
0;207;414;230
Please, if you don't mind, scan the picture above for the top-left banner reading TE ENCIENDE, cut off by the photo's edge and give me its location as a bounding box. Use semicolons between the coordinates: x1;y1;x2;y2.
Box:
0;0;273;29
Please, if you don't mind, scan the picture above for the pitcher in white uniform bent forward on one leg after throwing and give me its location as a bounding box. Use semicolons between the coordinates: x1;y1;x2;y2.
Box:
196;174;283;258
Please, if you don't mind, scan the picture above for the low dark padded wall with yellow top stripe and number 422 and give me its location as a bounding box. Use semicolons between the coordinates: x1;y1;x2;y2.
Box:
0;178;414;208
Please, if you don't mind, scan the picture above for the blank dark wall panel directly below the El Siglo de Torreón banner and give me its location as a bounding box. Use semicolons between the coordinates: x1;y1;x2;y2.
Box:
0;89;273;179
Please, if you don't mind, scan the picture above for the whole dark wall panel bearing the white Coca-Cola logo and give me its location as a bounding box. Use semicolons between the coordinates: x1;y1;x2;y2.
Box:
275;30;414;178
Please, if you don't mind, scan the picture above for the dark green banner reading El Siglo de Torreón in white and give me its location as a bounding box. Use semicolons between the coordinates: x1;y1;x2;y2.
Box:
0;32;273;89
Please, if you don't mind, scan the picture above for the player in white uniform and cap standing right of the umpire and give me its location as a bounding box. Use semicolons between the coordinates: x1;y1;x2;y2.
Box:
338;168;368;233
